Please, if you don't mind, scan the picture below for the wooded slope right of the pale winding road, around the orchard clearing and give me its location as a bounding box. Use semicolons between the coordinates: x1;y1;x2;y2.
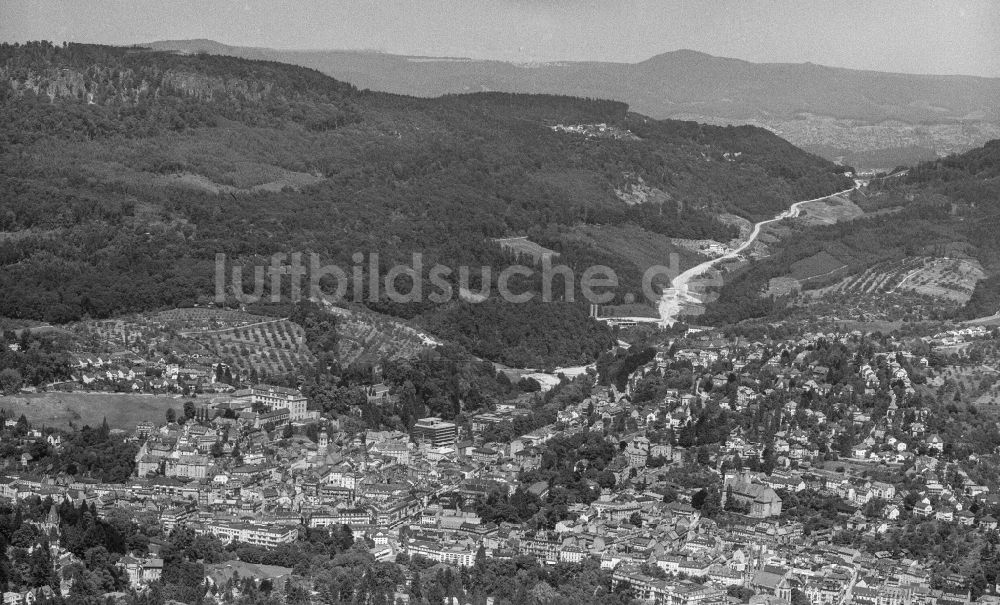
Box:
702;140;1000;323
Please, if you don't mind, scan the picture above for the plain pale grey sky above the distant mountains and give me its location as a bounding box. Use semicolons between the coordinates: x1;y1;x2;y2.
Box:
0;0;1000;76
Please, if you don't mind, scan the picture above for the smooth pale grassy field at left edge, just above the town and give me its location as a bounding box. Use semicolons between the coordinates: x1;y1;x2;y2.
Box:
0;391;188;431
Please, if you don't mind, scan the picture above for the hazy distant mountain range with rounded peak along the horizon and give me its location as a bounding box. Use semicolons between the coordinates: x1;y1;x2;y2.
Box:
148;40;1000;167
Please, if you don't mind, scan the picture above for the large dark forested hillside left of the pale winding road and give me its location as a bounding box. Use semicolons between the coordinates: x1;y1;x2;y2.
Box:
0;42;845;362
